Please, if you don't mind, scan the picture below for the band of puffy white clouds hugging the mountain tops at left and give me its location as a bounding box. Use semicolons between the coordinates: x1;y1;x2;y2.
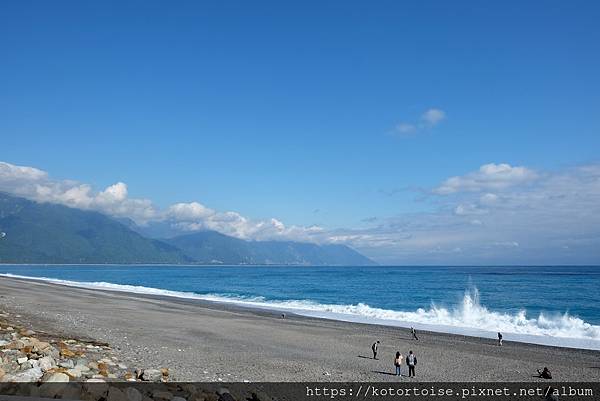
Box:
0;162;321;241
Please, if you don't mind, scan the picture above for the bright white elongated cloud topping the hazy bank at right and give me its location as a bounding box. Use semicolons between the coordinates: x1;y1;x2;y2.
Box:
433;163;538;195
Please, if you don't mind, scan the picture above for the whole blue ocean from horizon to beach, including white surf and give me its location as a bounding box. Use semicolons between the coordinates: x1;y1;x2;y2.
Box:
0;265;600;350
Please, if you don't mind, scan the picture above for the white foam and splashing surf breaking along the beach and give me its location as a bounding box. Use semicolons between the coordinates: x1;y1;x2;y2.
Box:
0;273;600;349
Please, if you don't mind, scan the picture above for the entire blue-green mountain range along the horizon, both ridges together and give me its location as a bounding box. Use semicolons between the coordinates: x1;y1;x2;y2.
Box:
0;193;375;265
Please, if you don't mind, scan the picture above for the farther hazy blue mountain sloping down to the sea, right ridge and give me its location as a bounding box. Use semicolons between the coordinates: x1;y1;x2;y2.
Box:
164;231;375;266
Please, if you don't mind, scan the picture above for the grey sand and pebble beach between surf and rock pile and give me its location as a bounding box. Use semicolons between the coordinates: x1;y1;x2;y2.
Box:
0;277;600;381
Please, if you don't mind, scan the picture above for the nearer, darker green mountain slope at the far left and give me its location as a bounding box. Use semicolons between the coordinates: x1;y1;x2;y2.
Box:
0;193;193;263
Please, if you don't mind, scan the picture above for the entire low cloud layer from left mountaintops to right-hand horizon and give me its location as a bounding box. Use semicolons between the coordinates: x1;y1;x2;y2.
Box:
0;162;600;264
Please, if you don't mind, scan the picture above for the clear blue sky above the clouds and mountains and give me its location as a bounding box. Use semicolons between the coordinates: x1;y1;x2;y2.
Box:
0;1;600;263
